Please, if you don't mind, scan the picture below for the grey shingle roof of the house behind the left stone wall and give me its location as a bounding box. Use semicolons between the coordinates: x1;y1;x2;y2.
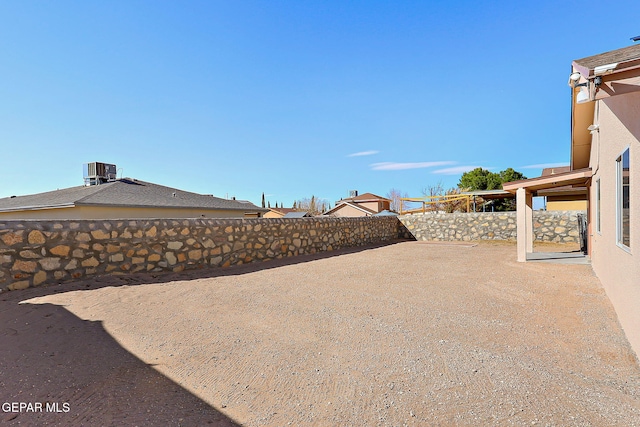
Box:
0;178;267;212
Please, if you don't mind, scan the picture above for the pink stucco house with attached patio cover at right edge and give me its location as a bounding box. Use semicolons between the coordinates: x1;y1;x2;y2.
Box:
504;44;640;355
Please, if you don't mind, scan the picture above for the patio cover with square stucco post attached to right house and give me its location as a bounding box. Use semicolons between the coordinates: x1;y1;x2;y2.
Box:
502;168;591;262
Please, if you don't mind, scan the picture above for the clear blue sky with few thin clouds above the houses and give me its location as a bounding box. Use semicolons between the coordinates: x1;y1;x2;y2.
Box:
0;0;640;206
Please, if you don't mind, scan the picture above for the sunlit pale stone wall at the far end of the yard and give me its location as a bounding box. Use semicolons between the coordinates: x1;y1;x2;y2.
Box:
400;211;584;243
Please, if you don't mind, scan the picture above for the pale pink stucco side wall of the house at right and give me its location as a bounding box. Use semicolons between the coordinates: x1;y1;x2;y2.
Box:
589;92;640;355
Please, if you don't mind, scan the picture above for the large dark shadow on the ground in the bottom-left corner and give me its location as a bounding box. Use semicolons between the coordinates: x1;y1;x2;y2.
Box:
0;291;239;426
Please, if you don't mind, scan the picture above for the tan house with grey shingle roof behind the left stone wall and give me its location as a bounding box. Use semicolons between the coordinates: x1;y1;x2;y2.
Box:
0;178;267;220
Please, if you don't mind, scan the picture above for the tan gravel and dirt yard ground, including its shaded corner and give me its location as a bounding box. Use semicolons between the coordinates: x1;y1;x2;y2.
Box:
0;242;640;426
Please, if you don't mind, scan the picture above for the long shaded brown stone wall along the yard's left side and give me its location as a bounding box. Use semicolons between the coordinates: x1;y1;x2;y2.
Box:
0;217;406;290
